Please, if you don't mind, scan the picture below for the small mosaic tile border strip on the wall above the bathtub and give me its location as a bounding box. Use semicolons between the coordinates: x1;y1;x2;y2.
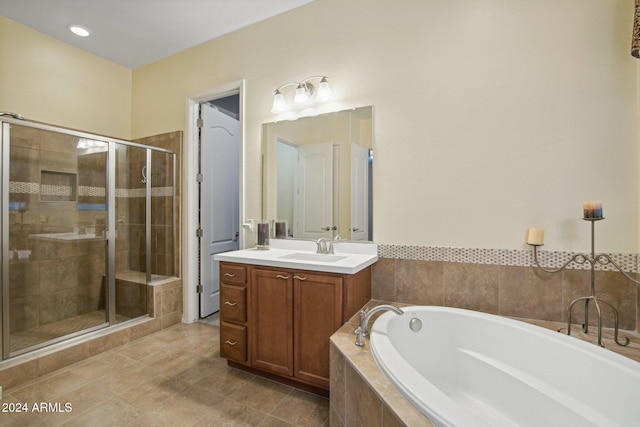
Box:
378;244;640;273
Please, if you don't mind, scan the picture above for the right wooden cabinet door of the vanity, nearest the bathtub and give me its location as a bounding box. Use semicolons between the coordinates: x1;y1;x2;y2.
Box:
293;272;342;389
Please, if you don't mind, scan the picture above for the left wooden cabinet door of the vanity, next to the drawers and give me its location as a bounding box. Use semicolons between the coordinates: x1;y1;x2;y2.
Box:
251;268;293;376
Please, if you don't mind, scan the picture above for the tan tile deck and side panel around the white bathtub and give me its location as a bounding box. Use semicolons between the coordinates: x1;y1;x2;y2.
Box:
329;300;640;427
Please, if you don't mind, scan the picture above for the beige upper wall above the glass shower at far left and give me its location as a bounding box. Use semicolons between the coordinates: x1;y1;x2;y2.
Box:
0;16;132;139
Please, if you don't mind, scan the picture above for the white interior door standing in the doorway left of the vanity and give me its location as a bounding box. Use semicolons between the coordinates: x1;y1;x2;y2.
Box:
200;104;240;317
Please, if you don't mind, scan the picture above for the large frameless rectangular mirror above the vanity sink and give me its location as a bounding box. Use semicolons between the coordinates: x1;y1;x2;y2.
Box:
262;106;373;240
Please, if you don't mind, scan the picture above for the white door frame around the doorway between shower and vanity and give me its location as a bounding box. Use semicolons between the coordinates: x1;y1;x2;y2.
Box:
182;80;245;323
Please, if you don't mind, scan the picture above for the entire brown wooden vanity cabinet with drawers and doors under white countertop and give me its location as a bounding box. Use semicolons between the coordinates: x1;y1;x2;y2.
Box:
220;262;371;390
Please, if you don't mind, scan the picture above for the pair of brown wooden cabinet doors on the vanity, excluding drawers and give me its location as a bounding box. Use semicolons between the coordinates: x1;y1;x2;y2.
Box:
251;267;343;388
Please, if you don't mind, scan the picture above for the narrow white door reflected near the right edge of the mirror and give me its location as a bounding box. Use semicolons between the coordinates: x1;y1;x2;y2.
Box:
349;144;369;240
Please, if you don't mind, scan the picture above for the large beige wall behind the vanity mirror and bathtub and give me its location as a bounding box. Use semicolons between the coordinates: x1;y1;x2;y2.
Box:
133;0;638;252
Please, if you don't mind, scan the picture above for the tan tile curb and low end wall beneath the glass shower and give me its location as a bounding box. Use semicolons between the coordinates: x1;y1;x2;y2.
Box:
0;278;182;389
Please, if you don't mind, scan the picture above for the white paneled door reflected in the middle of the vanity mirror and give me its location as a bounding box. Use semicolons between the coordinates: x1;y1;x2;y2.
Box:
294;142;334;239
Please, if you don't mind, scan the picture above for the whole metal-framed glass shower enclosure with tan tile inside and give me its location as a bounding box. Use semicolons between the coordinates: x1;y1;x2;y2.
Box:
0;117;176;360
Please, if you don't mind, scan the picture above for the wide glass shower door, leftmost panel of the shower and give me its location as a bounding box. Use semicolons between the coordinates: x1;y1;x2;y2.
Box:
2;123;108;358
